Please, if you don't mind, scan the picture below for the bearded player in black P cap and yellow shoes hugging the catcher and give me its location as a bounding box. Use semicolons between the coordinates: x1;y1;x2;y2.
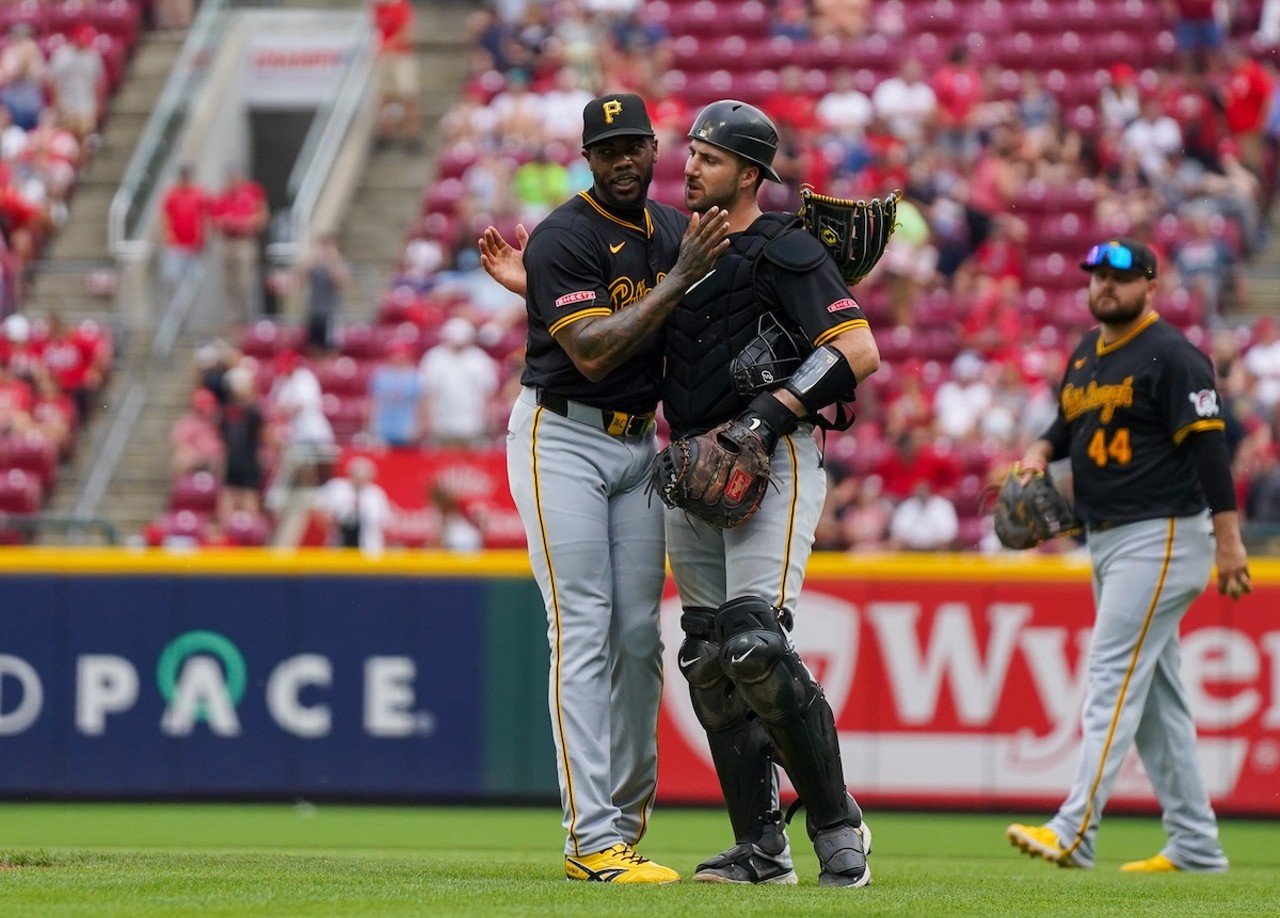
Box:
494;93;727;883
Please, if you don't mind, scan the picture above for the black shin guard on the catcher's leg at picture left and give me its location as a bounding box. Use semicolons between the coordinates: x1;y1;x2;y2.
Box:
677;608;778;842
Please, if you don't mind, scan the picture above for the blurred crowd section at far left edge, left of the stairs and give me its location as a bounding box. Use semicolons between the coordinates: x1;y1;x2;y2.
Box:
0;0;146;543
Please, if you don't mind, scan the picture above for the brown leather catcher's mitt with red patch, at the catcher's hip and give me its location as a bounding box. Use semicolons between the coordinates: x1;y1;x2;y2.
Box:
649;421;769;529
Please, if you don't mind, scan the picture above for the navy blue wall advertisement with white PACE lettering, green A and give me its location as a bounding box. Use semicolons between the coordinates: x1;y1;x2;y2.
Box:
0;576;484;796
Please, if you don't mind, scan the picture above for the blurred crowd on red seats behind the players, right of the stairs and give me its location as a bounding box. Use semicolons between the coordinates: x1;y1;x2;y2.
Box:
145;0;1280;551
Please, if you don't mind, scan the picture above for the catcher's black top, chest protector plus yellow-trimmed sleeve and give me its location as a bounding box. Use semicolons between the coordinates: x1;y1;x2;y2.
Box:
663;214;867;437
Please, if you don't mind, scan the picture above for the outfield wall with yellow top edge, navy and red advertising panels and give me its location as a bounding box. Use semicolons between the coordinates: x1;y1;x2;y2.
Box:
0;549;1280;816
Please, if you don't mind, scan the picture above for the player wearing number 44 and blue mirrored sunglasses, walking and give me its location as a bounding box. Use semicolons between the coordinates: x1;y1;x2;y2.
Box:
1006;238;1249;873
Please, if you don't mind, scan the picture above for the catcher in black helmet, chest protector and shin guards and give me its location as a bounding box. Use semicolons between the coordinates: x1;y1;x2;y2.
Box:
480;100;879;887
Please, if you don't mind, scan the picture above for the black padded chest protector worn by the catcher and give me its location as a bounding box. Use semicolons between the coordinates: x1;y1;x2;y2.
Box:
662;214;804;437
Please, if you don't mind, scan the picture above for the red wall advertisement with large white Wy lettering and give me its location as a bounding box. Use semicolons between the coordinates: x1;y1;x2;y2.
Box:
658;560;1280;816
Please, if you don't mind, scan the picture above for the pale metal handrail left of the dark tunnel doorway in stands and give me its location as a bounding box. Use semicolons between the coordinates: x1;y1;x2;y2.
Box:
106;0;229;257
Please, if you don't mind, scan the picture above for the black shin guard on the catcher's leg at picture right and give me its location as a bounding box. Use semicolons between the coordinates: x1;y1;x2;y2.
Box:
716;597;861;837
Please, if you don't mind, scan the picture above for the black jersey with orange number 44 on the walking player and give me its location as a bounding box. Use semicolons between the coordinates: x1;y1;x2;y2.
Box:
1044;312;1225;524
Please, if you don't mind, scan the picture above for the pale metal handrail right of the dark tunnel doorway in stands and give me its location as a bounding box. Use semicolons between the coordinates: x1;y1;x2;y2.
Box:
268;18;376;265
